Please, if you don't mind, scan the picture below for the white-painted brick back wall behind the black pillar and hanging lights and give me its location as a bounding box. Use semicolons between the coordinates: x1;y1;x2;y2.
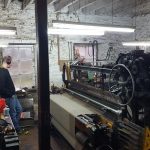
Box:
0;1;150;86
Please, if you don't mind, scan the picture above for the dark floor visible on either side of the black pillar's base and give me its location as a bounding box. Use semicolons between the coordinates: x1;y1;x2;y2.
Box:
19;126;73;150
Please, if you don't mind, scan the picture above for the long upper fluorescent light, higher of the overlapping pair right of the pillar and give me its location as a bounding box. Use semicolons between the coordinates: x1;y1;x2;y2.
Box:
52;20;135;33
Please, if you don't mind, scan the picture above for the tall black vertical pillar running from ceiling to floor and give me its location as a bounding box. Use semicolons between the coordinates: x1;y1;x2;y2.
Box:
35;0;50;150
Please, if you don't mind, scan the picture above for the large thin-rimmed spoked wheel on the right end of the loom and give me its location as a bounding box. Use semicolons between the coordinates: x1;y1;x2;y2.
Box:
109;64;135;106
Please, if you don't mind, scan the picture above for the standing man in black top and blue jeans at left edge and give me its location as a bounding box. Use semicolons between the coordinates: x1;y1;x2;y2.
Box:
0;56;22;132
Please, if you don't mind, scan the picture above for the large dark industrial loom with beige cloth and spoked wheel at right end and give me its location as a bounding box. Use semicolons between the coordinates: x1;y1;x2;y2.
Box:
51;50;150;150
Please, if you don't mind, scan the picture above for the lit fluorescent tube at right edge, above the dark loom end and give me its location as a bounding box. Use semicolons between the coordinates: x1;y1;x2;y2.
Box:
122;41;150;46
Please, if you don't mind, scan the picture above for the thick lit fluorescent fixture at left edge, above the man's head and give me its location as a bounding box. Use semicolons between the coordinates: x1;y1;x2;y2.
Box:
0;27;16;35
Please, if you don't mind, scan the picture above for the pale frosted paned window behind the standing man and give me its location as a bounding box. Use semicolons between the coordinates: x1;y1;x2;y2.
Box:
3;47;35;88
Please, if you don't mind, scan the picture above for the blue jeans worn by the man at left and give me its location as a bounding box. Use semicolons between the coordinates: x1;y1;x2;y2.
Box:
6;95;22;132
